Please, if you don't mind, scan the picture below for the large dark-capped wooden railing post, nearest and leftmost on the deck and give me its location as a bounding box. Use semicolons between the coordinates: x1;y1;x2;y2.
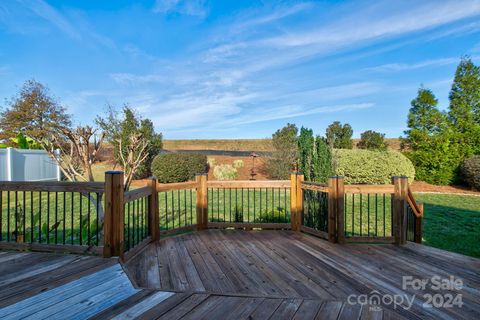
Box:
103;171;124;257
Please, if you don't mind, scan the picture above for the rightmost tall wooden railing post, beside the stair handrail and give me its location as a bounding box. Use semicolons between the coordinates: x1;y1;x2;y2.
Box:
392;177;408;245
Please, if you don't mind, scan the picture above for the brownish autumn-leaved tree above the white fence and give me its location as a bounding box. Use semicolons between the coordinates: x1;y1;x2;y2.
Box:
0;80;71;145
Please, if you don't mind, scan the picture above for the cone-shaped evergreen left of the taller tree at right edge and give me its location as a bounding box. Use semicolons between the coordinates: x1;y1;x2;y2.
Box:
403;88;462;184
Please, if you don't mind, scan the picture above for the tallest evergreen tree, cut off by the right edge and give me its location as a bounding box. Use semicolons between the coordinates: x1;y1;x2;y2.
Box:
448;57;480;156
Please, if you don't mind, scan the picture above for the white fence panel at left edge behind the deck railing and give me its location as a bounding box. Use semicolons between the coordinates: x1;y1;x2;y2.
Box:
0;148;61;181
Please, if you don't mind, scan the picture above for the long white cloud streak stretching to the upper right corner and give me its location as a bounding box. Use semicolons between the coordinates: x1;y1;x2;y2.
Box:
264;0;480;48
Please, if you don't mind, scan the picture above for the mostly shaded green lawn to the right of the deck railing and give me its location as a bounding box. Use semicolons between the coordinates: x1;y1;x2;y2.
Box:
415;194;480;258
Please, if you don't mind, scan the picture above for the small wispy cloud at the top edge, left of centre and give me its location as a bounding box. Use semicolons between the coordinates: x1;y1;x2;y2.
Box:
153;0;208;18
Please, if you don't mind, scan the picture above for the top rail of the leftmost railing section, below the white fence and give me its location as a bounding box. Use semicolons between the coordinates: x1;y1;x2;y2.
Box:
0;181;105;193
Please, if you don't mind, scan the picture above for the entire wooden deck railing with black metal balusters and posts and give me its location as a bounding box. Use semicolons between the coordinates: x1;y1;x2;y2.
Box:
0;171;423;259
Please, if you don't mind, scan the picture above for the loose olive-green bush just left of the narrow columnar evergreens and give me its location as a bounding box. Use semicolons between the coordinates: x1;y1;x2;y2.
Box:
265;123;298;179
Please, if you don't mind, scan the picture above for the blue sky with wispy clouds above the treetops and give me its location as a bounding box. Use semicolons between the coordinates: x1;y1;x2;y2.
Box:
0;0;480;139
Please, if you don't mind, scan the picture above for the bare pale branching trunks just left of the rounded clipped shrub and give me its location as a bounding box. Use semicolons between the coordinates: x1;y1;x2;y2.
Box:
117;133;149;191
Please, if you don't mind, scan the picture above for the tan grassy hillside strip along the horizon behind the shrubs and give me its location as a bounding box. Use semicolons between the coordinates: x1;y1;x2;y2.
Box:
163;138;400;151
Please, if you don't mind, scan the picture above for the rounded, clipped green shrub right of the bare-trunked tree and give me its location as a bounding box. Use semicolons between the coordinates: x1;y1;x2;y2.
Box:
152;153;207;183
